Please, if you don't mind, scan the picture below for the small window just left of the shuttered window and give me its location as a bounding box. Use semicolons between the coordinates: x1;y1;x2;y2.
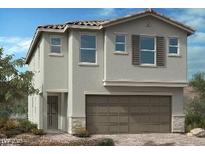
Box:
115;35;125;52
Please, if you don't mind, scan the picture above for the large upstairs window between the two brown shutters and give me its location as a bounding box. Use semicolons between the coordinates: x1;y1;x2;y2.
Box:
140;36;156;65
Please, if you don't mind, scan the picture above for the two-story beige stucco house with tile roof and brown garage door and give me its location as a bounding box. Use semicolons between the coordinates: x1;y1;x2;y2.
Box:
26;10;194;134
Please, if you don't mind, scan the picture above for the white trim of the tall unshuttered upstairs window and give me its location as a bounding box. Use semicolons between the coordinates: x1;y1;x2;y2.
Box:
78;33;98;66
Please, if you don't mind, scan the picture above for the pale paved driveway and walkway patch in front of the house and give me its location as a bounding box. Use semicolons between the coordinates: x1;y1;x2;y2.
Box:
46;133;205;146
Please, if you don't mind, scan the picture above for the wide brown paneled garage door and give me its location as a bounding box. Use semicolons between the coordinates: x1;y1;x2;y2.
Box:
86;95;171;134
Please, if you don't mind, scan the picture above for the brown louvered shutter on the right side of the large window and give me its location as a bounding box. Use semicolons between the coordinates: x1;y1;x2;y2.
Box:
157;36;165;66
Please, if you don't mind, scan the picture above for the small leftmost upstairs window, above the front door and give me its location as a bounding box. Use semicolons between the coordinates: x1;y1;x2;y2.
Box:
51;37;61;53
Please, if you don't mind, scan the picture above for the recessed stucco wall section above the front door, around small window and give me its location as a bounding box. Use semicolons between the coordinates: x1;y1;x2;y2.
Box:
43;33;69;90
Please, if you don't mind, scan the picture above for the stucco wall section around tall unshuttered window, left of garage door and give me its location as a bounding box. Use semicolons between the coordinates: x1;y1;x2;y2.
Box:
72;31;103;117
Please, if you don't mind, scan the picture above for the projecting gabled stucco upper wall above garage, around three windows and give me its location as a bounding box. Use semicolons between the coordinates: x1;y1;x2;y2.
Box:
105;17;187;82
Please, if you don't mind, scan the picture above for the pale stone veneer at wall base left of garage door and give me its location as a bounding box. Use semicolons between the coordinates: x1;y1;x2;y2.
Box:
68;117;86;134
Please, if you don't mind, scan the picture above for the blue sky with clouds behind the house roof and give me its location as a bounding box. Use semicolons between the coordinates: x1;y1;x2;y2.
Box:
0;8;205;79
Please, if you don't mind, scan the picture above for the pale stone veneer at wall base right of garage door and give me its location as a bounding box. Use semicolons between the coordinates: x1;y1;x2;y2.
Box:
172;115;185;133
